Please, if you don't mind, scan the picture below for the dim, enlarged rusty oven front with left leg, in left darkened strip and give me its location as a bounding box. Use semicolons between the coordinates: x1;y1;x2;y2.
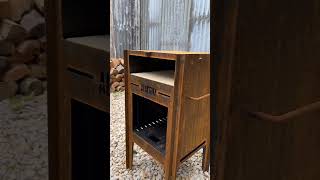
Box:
47;0;110;180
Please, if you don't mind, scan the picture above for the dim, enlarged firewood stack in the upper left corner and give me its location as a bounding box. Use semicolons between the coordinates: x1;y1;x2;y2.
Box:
0;0;47;100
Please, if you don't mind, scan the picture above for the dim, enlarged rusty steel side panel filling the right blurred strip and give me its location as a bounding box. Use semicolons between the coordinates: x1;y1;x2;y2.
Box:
211;0;320;180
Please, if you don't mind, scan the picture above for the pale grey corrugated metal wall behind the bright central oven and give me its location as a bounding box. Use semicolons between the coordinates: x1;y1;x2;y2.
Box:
111;0;210;57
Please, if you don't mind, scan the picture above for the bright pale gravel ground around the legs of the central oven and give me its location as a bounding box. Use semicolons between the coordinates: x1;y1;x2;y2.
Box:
110;92;210;180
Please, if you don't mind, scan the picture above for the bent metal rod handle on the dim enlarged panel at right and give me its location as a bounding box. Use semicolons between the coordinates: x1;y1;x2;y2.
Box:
248;101;320;123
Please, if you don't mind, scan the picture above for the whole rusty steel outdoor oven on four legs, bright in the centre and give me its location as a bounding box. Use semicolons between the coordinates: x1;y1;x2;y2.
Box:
125;51;210;179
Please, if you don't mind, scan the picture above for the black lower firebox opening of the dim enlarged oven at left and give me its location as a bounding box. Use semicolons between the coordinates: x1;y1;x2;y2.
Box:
71;99;110;180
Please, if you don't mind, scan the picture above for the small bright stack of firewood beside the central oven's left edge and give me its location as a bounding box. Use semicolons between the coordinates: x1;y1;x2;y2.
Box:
110;59;125;92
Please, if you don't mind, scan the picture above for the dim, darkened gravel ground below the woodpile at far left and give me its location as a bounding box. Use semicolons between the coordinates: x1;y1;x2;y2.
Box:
0;93;48;180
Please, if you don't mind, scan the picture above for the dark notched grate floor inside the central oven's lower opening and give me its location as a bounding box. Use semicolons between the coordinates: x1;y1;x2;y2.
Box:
134;118;167;156
